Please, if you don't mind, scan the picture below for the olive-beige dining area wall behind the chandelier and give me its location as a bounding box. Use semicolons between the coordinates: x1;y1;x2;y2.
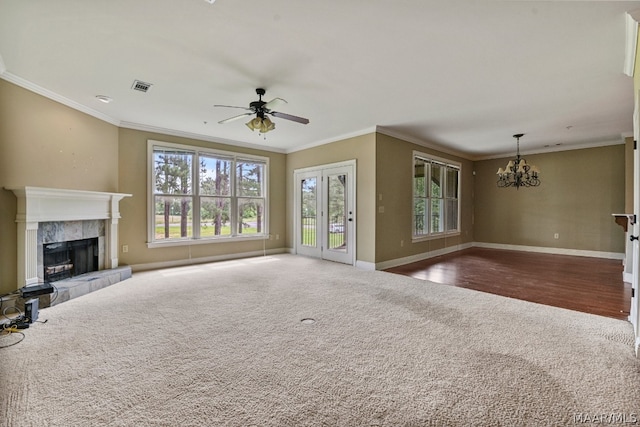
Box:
474;144;625;253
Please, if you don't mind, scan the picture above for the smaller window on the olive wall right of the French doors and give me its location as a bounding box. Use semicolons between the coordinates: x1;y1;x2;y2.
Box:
412;152;460;239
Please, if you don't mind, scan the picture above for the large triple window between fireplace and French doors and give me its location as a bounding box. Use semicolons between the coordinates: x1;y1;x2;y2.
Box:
149;141;269;244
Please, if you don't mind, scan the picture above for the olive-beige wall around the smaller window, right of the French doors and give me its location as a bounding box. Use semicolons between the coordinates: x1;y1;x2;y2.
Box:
375;133;473;263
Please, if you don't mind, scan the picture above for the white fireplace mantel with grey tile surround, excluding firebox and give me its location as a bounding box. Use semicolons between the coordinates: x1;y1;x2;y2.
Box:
11;187;131;300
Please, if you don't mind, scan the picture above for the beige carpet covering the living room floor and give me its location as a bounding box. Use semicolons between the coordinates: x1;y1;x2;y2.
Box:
0;255;640;427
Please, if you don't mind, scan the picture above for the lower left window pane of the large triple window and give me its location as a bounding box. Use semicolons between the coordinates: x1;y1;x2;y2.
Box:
154;196;193;240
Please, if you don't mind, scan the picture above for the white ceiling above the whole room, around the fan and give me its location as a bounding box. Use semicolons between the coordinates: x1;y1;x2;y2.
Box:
0;0;640;159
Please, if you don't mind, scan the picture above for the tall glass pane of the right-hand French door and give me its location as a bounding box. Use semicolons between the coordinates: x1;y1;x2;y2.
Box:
327;175;347;251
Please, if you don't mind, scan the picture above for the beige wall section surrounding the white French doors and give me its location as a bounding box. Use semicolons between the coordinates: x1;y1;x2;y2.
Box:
286;133;376;263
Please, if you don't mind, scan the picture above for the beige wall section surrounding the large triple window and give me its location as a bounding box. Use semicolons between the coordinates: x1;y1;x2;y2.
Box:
119;129;286;268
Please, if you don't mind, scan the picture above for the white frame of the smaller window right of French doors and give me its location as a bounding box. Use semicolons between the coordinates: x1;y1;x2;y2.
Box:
411;151;462;242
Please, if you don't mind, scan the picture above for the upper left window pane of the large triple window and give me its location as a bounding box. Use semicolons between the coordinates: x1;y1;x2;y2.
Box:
153;149;193;194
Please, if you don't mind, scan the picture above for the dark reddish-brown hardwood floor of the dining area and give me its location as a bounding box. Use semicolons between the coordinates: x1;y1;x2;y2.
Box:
386;248;631;319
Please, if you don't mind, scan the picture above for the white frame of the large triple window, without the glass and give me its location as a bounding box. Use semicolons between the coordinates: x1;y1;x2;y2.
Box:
147;140;269;248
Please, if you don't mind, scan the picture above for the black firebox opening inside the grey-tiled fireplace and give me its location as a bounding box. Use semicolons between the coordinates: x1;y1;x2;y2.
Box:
43;237;99;282
